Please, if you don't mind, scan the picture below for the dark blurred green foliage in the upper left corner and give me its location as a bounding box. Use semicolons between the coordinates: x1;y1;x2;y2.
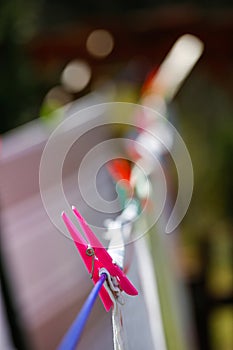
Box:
0;0;46;133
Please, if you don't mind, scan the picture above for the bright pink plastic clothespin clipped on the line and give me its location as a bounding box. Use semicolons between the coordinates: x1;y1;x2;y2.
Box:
62;207;138;311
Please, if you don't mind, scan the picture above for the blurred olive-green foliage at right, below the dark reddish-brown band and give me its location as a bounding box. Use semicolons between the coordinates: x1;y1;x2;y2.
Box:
177;69;233;235
